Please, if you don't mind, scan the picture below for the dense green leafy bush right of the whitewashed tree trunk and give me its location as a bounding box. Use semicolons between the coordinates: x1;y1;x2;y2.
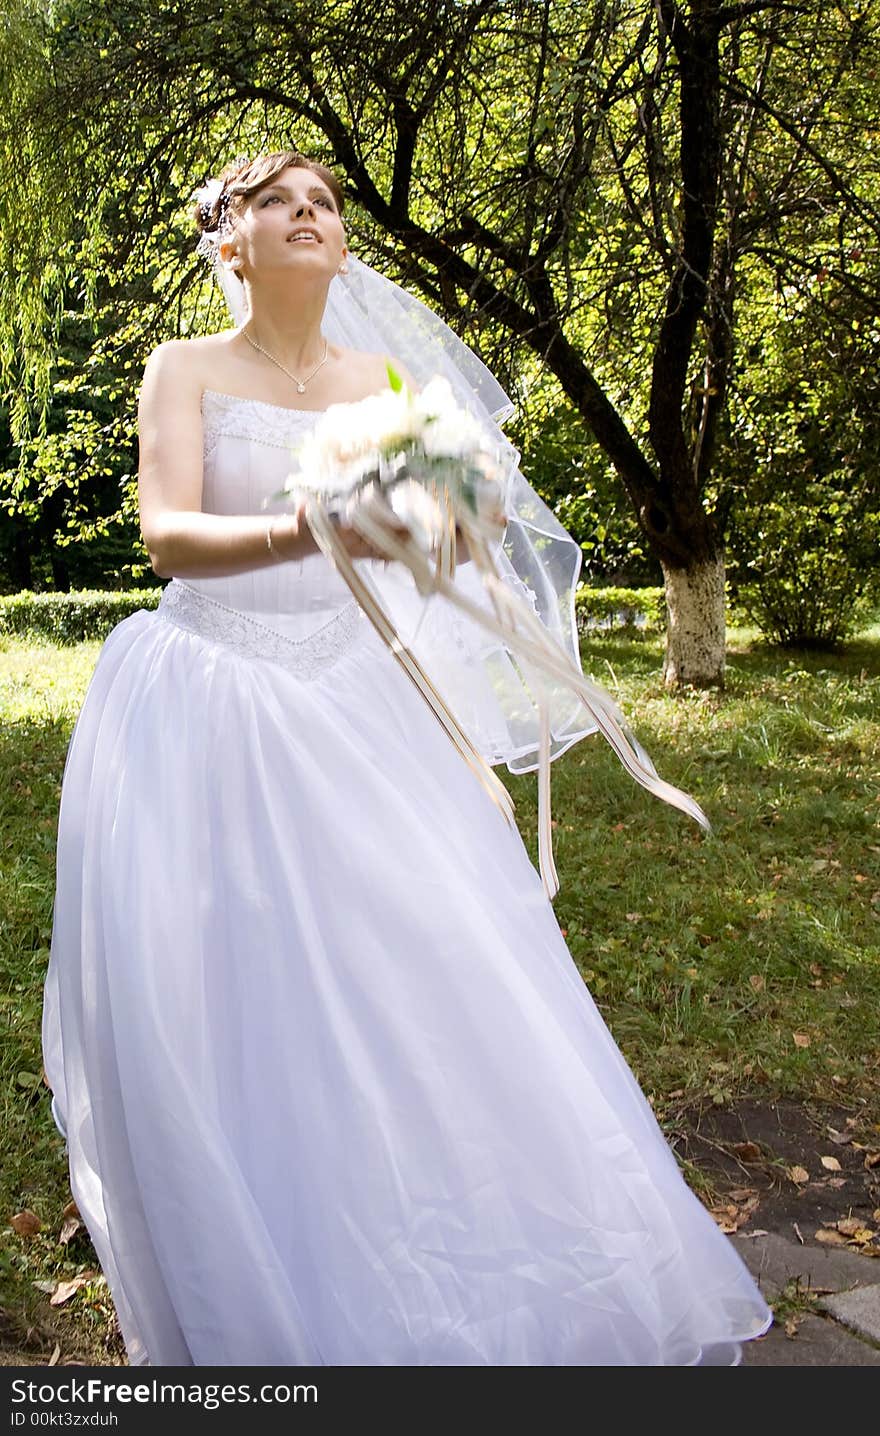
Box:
724;269;880;648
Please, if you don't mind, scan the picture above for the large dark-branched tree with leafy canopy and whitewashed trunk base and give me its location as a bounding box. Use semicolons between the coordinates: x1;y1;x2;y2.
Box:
0;0;879;684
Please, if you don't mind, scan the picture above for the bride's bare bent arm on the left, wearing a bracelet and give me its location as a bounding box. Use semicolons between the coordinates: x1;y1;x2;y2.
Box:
138;340;317;579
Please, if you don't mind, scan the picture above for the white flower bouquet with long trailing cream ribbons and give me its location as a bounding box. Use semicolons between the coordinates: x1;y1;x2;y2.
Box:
276;365;709;898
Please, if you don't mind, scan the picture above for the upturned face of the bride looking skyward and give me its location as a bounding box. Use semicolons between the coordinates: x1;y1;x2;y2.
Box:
221;167;349;283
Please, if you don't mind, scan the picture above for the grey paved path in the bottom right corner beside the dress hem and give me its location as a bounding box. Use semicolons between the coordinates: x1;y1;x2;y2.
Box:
731;1232;880;1366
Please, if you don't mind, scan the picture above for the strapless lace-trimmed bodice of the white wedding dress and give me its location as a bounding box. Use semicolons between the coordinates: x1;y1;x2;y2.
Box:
175;389;352;638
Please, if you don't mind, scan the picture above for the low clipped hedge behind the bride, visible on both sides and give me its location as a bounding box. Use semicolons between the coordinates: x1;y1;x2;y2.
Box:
0;584;666;643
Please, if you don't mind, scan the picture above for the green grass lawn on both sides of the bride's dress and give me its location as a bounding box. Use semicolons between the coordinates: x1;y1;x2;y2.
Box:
0;629;880;1360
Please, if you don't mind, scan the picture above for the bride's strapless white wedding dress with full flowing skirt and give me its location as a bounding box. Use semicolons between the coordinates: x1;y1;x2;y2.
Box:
43;391;771;1366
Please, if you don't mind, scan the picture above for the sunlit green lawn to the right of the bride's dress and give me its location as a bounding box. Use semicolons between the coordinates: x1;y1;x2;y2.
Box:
512;630;880;1106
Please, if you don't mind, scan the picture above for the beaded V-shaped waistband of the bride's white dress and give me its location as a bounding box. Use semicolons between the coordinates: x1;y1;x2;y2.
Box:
155;579;363;679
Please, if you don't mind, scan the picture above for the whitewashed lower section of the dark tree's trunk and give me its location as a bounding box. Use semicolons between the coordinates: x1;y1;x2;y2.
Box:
663;559;725;688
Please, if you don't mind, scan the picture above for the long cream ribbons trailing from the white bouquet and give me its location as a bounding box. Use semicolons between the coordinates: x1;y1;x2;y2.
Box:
304;487;711;899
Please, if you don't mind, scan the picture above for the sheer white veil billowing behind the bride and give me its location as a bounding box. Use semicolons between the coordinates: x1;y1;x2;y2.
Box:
200;234;597;773
